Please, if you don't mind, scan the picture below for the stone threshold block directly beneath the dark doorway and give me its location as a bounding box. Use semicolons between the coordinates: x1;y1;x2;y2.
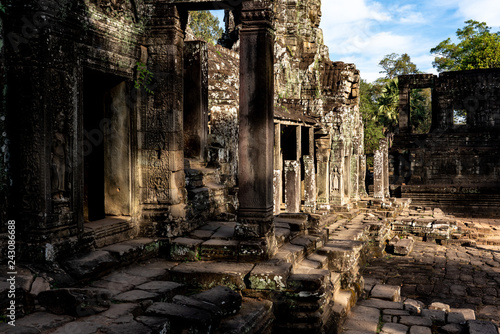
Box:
84;216;135;248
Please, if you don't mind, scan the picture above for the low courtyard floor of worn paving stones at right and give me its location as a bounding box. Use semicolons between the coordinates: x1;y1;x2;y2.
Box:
363;231;500;325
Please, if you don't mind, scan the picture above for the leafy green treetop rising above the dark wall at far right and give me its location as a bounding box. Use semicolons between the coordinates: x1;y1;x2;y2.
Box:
431;20;500;72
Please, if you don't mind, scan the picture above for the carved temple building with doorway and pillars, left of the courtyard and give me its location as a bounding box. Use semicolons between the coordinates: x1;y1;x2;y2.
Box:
0;0;365;261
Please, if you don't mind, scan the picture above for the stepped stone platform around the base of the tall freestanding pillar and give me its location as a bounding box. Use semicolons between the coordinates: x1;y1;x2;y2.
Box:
168;203;403;333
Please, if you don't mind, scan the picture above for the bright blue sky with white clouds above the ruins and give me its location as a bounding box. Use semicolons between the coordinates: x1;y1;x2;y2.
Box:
211;0;500;82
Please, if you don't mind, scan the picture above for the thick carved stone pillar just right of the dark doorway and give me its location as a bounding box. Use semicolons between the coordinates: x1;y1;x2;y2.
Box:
142;2;187;228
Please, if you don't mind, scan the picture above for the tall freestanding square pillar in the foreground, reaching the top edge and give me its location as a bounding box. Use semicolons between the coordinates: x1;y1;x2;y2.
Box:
235;1;276;258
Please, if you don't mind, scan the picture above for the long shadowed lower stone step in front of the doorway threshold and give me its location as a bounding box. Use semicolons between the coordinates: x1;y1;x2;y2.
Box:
63;238;160;281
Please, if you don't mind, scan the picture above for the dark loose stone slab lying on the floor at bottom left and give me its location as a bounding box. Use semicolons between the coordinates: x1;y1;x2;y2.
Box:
38;289;110;317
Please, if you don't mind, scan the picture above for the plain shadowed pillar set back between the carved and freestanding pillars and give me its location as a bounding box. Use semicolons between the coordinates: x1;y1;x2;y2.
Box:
184;41;208;161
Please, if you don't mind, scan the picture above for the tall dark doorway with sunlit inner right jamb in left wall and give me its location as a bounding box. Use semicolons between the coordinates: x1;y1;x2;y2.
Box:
83;69;131;222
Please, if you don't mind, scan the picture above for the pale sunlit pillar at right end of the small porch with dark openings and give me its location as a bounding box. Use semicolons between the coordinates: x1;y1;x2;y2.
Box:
316;136;331;210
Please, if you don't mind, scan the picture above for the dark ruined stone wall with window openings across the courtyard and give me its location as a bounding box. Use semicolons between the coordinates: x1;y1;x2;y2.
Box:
391;69;500;216
